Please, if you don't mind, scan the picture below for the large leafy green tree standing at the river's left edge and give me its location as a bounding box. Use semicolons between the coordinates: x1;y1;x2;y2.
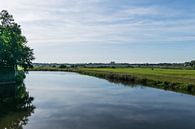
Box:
0;10;35;71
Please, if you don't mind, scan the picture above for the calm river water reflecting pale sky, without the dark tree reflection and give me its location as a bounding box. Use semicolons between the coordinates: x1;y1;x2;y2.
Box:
3;72;195;129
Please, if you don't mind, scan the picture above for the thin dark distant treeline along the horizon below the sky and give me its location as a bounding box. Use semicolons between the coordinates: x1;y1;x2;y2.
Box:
33;61;195;69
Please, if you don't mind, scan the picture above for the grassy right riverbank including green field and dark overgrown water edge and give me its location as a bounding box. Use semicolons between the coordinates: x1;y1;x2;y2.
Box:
32;67;195;94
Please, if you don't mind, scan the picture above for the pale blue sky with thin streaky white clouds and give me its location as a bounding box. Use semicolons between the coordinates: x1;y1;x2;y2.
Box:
0;0;195;63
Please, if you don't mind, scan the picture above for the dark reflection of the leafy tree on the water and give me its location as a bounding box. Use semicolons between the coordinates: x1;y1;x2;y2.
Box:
0;83;35;129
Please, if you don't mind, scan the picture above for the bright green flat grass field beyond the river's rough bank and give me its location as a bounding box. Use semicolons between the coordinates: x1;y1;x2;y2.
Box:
80;68;195;85
